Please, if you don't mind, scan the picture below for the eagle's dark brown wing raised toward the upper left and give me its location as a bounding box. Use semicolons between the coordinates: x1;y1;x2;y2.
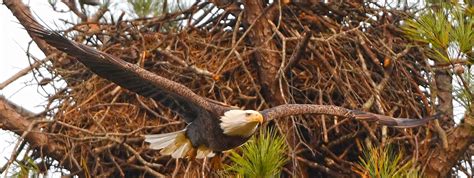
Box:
27;21;217;123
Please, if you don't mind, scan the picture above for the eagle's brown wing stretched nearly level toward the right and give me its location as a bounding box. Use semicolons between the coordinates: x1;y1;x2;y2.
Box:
261;104;436;128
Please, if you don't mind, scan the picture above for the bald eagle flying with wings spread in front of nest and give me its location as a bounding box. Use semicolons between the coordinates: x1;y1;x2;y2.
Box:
27;23;430;158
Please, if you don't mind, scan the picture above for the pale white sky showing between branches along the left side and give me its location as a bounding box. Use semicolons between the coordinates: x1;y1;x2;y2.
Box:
0;0;126;177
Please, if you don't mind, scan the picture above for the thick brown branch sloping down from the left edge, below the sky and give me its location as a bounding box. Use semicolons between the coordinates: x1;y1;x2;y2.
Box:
0;98;80;172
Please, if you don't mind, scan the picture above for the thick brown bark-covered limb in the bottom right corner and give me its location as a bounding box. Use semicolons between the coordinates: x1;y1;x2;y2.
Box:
424;114;474;177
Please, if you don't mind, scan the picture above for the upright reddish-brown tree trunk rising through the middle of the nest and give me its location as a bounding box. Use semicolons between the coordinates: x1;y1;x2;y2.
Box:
243;0;305;176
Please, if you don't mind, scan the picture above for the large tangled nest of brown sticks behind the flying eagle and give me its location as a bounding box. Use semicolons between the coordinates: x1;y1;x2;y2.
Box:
31;3;430;176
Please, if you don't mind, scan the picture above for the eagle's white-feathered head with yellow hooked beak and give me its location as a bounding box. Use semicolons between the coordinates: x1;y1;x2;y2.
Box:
220;110;263;137
